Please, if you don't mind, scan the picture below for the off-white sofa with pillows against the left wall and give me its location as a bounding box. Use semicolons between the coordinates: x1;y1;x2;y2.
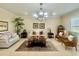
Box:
0;33;19;48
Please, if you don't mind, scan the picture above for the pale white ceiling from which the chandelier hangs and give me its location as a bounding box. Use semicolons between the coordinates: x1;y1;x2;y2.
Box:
0;3;79;16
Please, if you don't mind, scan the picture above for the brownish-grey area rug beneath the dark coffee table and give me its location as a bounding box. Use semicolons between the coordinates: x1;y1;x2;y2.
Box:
16;41;58;51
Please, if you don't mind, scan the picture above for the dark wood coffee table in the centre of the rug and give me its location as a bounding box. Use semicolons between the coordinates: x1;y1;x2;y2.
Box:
28;36;46;47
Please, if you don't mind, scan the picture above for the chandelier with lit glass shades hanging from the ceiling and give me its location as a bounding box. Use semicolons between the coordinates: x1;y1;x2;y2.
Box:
33;3;48;20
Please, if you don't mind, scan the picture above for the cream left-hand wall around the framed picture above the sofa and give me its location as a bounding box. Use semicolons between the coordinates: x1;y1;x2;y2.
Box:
0;8;16;32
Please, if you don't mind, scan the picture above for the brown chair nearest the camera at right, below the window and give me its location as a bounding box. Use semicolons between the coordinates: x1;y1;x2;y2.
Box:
63;31;78;51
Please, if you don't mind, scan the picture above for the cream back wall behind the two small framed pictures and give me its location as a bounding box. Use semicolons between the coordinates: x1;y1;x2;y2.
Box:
22;16;61;34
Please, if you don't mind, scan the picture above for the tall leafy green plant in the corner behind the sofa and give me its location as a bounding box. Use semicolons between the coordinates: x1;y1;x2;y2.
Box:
13;17;24;35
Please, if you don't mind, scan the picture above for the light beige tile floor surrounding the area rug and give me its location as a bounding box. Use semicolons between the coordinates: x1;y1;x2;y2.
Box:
0;39;79;56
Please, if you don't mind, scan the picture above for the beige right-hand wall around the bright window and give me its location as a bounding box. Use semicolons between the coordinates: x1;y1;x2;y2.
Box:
62;9;79;31
